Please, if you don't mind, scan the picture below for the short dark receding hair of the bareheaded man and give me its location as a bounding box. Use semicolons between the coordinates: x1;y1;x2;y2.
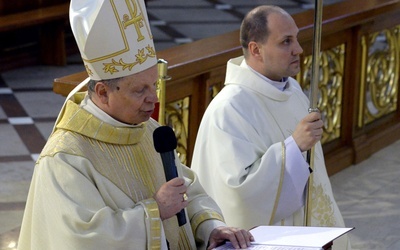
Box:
240;5;285;52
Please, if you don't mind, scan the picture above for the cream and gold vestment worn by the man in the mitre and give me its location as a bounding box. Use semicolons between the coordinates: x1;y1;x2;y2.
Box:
18;93;225;250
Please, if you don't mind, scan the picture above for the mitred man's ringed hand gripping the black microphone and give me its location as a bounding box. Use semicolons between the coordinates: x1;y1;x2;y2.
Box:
153;177;189;220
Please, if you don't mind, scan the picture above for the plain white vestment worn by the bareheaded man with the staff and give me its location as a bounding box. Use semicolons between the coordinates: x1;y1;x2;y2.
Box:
191;57;347;250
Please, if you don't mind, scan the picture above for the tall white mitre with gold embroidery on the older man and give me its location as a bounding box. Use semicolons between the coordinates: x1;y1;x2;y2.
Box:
70;0;157;80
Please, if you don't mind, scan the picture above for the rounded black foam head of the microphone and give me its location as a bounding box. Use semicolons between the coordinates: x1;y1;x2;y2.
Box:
153;126;178;153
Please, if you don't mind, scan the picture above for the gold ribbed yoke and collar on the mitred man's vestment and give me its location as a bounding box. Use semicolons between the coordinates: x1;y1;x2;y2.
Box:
49;101;165;202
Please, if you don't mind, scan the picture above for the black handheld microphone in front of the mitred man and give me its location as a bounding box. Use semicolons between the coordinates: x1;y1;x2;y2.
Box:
153;126;186;226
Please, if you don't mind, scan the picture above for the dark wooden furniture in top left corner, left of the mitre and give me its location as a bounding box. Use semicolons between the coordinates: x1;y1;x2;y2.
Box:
0;0;69;68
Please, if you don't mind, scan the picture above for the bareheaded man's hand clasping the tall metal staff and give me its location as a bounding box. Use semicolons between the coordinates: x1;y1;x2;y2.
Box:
292;112;324;152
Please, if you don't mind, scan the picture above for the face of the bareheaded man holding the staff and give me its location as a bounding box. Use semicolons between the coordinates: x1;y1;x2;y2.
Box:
259;13;303;81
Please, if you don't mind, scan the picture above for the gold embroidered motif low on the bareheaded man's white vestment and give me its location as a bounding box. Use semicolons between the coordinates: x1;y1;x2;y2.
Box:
312;185;336;227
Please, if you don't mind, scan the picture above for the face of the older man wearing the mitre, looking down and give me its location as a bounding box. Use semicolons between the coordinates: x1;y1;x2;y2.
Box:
103;65;158;124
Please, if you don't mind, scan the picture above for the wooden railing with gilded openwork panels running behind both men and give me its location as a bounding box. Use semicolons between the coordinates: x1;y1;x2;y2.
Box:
54;0;400;174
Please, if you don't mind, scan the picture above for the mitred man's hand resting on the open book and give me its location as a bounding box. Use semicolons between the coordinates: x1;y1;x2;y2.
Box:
207;227;254;249
